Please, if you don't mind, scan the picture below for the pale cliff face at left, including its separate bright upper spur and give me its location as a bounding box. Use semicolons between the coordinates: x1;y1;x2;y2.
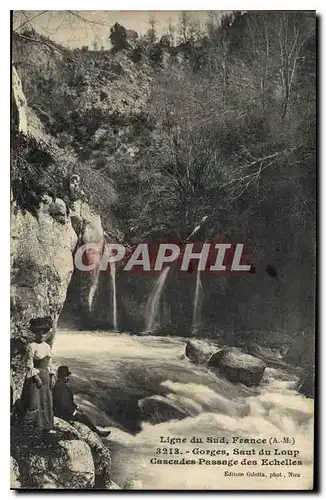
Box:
11;66;104;399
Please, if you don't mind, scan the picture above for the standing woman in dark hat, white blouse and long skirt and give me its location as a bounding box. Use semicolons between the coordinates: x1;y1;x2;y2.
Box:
19;316;55;438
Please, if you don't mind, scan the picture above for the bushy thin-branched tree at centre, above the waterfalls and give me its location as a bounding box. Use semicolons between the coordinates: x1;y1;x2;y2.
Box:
126;73;225;238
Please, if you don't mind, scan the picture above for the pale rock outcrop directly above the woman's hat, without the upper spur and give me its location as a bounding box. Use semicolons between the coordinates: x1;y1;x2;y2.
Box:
11;197;77;396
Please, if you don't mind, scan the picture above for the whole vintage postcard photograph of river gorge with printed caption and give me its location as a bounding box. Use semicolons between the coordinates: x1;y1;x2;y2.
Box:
10;10;317;491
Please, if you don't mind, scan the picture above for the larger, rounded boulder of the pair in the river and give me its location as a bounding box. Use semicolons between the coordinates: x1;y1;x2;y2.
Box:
208;347;266;387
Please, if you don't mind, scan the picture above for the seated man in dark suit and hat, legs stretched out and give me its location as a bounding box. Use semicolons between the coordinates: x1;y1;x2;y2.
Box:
53;366;111;437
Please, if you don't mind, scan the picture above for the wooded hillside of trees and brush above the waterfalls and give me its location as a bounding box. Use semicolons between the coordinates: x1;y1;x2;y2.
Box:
14;11;316;348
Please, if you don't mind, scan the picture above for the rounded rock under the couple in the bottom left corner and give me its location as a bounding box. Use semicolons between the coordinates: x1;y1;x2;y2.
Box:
11;418;119;489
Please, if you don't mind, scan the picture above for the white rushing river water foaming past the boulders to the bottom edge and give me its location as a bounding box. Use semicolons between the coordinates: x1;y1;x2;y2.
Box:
53;332;313;489
